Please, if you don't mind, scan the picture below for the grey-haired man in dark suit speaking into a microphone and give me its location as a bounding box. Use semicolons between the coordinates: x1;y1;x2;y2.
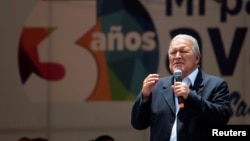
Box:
131;34;231;141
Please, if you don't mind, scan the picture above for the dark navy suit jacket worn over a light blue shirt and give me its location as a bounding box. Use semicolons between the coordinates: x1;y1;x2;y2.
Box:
131;69;231;141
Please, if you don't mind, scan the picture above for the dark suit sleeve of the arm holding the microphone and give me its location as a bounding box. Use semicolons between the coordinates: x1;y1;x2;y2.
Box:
185;79;231;125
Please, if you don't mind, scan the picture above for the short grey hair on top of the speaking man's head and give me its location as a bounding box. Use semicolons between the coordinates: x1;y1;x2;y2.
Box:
169;34;200;55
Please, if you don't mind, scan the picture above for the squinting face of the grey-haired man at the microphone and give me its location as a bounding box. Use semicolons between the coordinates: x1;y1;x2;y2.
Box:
168;38;200;77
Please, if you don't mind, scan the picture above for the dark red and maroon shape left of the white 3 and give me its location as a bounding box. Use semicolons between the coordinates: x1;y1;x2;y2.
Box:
19;27;65;84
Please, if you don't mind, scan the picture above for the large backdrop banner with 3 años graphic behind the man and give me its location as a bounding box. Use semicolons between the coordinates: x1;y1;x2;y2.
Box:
0;0;250;140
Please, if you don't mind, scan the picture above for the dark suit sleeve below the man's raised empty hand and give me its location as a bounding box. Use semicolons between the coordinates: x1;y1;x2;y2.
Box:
131;93;151;130
